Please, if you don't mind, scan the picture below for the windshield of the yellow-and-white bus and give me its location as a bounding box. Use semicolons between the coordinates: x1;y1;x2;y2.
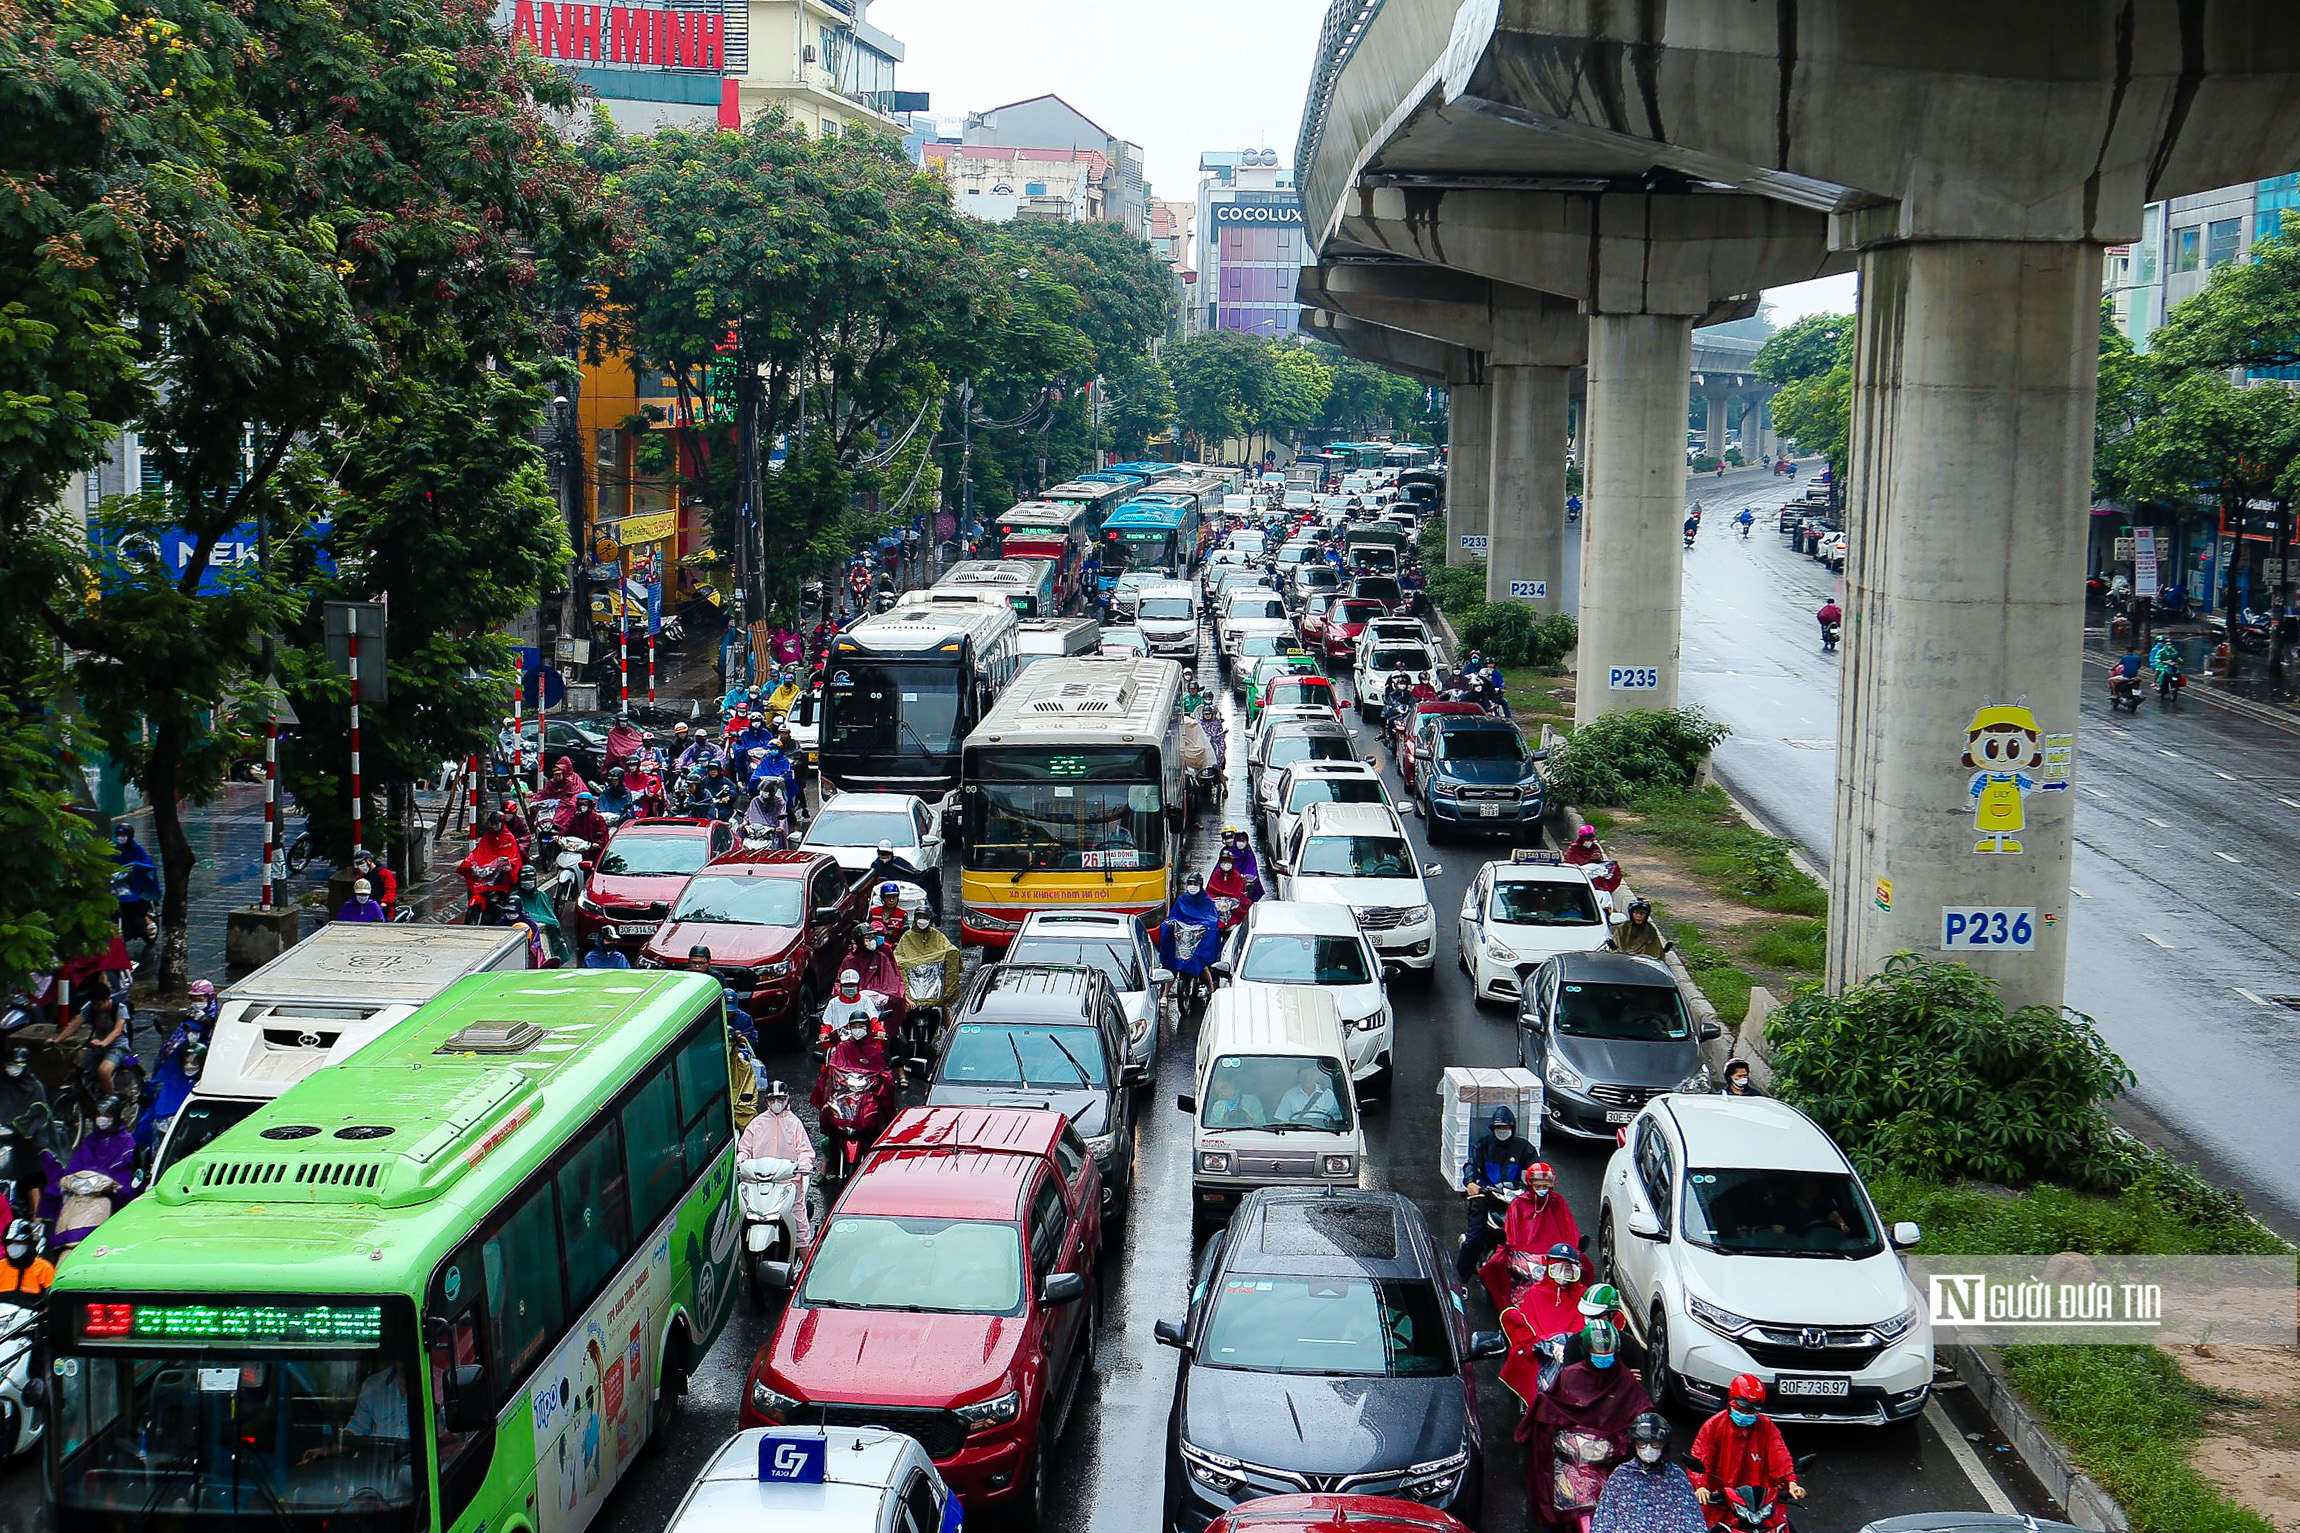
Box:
966;747;1166;876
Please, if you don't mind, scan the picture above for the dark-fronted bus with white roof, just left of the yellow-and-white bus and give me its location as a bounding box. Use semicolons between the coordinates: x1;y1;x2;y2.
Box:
817;600;1019;802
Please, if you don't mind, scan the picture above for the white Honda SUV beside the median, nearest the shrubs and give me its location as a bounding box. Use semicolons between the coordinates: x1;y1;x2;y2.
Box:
1596;1094;1932;1425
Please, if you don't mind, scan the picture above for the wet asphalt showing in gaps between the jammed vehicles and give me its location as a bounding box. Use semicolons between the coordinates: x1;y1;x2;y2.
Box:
575;611;2036;1533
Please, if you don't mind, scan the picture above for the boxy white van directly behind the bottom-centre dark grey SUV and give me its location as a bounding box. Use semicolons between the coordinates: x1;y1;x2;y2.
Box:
1175;986;1366;1234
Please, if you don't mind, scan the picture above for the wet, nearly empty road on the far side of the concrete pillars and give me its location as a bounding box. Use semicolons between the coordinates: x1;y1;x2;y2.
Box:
1681;471;2300;1237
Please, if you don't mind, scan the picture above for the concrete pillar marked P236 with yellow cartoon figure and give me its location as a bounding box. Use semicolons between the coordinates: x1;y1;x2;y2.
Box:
1830;239;2100;1007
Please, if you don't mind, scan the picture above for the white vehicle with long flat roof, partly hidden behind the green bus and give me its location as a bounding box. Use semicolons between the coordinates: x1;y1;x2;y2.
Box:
152;922;527;1181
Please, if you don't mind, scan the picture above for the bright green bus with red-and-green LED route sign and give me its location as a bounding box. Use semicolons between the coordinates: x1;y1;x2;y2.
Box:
41;970;738;1533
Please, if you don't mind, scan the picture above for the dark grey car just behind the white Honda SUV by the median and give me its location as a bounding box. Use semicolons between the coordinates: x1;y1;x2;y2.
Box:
1518;952;1718;1140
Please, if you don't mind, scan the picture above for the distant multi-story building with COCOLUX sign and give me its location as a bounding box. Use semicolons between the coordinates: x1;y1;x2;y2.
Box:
1189;149;1306;336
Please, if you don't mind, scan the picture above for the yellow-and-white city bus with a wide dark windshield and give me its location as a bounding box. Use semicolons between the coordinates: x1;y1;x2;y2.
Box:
959;657;1187;947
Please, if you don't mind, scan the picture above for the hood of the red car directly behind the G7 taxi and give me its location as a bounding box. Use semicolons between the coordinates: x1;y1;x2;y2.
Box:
768;1305;1030;1407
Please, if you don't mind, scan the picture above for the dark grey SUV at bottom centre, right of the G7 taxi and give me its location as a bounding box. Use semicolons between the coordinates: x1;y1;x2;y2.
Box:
1157;1188;1509;1533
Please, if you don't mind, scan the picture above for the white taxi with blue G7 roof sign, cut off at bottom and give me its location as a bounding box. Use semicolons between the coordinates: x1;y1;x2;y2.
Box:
665;1427;961;1533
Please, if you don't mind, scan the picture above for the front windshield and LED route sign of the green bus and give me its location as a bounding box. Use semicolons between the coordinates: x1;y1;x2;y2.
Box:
48;1296;430;1526
